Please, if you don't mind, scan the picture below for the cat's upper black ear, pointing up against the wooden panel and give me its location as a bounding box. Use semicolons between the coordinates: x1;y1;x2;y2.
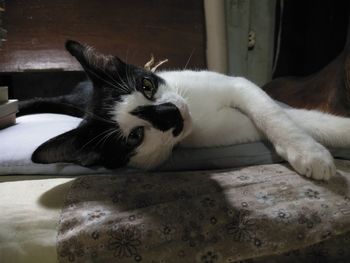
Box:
66;40;125;83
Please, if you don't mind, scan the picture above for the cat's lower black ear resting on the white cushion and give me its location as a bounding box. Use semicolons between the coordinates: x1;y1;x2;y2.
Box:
32;126;99;166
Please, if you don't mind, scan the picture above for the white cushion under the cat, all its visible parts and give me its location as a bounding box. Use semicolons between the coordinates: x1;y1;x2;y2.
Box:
0;114;350;175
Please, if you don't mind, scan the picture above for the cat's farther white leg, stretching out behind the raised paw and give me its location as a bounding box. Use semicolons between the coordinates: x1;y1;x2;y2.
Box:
285;108;350;148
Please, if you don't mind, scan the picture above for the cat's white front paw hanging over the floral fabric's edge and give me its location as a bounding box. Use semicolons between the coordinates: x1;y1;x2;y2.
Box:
276;142;336;180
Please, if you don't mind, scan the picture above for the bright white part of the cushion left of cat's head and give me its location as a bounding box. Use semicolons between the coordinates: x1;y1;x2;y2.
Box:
0;114;108;175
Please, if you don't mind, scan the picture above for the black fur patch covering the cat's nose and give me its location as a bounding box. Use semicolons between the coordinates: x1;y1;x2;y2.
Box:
131;102;184;137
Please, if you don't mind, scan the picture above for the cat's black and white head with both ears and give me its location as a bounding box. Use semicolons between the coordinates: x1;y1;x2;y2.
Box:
32;41;192;169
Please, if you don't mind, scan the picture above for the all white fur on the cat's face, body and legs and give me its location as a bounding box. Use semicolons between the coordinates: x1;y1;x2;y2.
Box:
114;71;350;180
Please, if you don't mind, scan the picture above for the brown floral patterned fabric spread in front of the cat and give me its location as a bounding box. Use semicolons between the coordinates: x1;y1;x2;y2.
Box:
57;160;350;263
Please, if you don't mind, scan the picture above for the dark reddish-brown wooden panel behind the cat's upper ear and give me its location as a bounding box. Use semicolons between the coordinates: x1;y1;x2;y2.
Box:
0;0;206;72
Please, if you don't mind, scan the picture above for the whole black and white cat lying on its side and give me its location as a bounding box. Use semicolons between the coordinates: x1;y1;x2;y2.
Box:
20;41;350;180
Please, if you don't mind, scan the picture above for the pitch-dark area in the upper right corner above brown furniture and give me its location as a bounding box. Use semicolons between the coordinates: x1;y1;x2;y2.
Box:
273;0;350;78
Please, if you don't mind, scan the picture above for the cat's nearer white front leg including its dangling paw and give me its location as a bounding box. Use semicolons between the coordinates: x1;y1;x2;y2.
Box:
226;77;336;180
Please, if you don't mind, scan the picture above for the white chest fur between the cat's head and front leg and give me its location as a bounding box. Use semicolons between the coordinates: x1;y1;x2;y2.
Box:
159;71;261;147
